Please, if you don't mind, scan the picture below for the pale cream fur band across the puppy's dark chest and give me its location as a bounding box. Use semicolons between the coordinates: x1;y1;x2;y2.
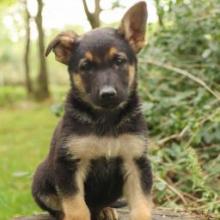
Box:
66;134;146;160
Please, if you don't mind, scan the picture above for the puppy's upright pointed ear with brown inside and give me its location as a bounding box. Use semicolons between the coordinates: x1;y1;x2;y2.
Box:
118;1;147;53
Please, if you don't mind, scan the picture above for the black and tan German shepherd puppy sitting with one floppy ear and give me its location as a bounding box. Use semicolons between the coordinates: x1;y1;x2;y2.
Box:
32;1;152;220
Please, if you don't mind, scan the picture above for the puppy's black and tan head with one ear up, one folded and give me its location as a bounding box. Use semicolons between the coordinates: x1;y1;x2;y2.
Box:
46;2;147;109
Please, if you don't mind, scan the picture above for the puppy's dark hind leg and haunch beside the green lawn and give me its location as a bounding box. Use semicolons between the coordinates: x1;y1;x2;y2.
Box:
32;162;63;220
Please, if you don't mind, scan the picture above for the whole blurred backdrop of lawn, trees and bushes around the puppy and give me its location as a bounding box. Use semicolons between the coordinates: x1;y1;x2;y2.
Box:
0;0;220;220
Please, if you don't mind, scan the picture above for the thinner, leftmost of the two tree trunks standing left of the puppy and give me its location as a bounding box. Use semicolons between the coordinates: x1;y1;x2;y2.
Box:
24;0;33;95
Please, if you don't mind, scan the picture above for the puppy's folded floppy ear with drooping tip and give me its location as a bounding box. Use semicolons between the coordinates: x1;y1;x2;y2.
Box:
45;31;78;65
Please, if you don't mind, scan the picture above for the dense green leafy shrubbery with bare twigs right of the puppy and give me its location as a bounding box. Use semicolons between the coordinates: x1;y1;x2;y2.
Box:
140;0;220;214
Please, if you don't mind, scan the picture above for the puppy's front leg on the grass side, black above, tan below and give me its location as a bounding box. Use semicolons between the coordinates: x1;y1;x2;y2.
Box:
55;150;90;220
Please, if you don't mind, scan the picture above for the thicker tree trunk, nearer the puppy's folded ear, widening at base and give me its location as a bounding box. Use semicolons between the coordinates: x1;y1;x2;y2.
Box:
35;0;50;100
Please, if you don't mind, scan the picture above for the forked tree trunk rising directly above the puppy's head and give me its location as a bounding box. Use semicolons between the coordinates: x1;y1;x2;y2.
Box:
83;0;102;29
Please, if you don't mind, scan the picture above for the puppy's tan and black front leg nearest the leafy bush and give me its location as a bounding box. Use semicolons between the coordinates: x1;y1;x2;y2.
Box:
123;156;152;220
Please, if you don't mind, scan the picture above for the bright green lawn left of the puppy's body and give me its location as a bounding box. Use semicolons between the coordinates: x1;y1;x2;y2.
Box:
0;104;58;220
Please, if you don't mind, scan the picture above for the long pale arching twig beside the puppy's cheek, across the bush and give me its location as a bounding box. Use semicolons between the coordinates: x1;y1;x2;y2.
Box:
143;60;220;101
